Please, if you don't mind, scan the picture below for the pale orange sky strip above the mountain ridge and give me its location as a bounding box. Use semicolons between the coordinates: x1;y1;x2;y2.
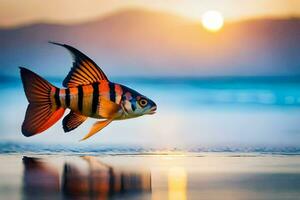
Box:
0;0;300;27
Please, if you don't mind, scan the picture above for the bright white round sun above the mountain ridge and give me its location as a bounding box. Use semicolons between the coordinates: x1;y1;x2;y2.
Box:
201;10;224;32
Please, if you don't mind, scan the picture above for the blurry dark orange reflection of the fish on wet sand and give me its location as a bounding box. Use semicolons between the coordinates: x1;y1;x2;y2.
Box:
23;156;151;199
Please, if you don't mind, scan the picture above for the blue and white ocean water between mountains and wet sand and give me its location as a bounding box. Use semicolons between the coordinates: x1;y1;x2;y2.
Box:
0;77;300;153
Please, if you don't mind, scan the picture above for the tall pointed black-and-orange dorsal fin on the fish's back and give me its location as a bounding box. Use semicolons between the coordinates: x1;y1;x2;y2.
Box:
49;42;108;87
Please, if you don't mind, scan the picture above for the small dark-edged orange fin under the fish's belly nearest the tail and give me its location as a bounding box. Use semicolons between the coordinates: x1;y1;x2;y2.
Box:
63;111;87;132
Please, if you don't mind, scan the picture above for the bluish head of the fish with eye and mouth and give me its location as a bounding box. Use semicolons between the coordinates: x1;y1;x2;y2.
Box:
122;85;157;117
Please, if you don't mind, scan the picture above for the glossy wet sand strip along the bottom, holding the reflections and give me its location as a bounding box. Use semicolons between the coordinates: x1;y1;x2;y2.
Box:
0;153;300;200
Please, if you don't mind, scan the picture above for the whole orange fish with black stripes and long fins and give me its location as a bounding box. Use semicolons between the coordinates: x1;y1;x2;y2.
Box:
19;42;157;141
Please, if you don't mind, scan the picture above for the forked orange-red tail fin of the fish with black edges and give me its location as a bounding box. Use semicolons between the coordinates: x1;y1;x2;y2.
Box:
20;67;65;137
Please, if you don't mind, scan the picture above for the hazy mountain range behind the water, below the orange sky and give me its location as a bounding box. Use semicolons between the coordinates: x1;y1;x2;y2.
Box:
0;10;300;76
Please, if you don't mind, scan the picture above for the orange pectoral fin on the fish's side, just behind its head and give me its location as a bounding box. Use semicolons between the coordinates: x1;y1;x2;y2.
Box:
98;98;121;119
